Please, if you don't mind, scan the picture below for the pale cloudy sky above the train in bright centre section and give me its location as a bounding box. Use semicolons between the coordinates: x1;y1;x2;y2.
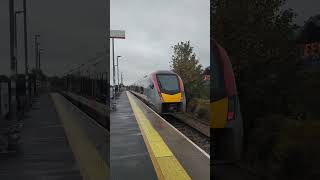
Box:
110;0;210;84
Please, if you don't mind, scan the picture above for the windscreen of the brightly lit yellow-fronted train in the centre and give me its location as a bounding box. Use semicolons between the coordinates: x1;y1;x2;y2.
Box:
157;74;180;94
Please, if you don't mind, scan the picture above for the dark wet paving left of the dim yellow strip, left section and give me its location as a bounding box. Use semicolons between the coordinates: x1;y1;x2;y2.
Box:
0;94;82;180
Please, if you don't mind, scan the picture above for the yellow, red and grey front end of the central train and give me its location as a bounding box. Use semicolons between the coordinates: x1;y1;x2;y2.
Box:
152;71;186;114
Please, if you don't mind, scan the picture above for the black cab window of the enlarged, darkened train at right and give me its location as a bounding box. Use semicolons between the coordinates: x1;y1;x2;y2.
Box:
210;44;227;101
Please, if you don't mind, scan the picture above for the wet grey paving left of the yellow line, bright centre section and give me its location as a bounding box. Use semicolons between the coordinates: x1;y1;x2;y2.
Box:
110;93;157;180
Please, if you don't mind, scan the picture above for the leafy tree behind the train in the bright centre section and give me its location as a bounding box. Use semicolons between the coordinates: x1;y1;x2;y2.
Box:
170;41;203;103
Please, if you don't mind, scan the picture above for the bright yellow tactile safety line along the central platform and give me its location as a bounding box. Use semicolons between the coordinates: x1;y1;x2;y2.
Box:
127;92;191;180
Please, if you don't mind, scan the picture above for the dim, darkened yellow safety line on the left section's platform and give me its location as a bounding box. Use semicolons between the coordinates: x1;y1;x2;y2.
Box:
51;93;109;180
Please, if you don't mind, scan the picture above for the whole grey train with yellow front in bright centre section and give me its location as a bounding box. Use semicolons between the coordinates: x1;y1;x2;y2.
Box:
129;70;186;114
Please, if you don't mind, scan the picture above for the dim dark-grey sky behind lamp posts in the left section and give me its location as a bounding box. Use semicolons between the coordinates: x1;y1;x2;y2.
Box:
0;0;109;75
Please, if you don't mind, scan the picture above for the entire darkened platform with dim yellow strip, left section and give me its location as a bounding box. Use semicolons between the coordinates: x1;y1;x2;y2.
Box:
0;93;109;180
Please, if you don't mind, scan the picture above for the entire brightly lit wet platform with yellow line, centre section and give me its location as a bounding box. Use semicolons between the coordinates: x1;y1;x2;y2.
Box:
110;91;210;180
